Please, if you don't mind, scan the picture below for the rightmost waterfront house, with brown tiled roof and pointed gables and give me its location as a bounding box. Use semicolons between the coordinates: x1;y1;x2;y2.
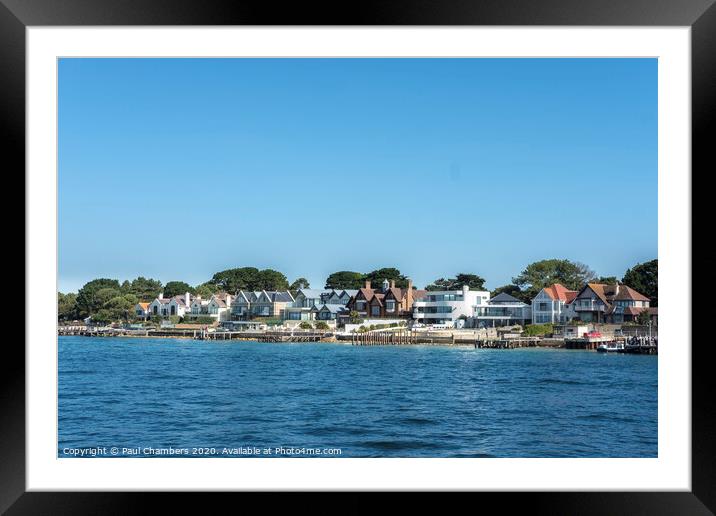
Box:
573;283;657;324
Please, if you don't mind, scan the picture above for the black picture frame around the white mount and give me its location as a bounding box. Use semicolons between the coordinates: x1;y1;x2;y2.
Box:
0;0;716;515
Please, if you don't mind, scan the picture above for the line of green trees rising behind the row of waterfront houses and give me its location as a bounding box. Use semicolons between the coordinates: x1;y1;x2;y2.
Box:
57;259;658;321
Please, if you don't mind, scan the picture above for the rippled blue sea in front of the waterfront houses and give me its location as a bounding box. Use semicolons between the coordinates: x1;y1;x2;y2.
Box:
58;337;658;457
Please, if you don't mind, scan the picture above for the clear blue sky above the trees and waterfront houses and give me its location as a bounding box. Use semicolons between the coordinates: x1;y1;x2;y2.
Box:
59;59;657;292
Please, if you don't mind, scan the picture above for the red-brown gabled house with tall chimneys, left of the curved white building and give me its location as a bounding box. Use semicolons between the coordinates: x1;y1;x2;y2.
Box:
346;279;425;319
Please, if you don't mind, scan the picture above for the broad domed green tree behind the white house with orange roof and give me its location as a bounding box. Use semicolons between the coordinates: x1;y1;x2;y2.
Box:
512;259;595;299
